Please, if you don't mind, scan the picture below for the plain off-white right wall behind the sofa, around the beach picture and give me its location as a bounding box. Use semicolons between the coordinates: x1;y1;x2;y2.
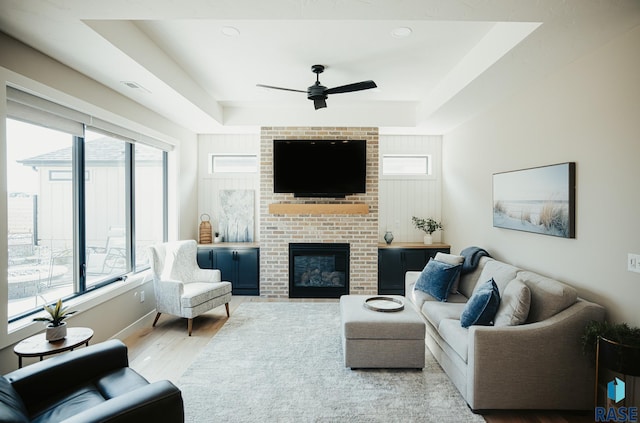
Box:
443;27;640;326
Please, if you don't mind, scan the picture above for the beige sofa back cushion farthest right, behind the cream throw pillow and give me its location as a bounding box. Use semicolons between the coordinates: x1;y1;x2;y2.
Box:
518;270;578;323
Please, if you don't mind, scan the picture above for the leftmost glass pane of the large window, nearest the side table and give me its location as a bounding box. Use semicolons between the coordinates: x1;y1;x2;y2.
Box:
6;119;74;318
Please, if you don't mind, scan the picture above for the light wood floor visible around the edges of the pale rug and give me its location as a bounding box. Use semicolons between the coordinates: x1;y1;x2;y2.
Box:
123;296;593;423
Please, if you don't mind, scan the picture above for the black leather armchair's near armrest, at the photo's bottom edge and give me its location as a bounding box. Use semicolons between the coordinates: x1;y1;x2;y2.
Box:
63;380;184;423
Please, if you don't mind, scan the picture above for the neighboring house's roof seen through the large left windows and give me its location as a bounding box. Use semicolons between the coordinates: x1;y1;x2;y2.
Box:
18;137;162;167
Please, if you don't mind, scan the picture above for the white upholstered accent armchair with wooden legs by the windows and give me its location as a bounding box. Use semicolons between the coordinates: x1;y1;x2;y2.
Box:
149;240;231;336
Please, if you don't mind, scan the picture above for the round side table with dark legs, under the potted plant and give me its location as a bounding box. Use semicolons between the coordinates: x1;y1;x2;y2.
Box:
13;328;93;368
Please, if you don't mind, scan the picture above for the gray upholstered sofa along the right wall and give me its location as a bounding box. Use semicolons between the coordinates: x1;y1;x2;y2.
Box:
405;257;605;412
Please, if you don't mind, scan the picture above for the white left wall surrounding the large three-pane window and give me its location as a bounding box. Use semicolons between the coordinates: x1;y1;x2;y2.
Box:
0;33;197;373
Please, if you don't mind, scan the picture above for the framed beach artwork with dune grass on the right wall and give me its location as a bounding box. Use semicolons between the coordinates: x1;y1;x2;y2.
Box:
493;162;576;238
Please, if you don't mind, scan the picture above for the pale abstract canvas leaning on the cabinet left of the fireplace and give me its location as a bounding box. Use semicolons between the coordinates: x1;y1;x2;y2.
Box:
218;189;254;242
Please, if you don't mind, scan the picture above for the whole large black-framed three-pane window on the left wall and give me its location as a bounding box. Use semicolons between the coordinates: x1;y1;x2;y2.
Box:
6;89;167;321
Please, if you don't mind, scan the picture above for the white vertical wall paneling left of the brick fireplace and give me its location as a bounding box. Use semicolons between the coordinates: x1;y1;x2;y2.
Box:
198;134;260;241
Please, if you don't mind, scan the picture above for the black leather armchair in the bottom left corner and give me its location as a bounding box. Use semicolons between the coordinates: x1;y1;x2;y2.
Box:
0;339;184;423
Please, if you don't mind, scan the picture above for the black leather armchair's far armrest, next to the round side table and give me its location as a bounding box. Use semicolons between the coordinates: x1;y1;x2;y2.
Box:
5;339;129;409
